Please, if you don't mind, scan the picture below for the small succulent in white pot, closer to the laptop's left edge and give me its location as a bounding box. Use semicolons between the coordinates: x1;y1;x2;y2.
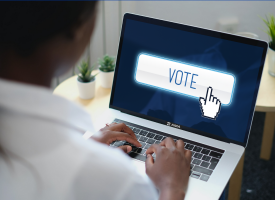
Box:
98;55;115;88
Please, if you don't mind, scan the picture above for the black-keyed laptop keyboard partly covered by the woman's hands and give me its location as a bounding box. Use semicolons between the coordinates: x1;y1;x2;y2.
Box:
110;119;224;181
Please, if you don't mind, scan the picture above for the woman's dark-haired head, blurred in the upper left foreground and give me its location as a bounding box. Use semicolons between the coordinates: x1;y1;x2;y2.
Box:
0;1;96;86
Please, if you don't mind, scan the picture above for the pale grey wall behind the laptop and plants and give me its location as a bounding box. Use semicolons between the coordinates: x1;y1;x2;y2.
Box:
52;1;275;88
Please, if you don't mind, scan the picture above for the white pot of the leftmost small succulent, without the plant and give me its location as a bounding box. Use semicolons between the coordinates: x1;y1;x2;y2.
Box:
77;78;95;99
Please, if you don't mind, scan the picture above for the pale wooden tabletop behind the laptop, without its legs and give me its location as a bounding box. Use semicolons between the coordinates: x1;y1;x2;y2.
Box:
53;59;275;115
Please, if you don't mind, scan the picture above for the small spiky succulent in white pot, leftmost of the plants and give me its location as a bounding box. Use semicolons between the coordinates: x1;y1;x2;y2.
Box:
77;61;97;99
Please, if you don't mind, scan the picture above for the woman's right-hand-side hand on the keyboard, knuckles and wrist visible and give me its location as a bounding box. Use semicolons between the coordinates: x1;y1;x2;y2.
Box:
146;138;192;200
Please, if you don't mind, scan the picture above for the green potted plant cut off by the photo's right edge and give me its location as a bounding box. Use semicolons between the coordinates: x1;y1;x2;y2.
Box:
263;15;275;76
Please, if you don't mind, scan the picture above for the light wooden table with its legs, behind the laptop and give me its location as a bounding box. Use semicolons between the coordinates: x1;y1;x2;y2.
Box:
53;62;275;200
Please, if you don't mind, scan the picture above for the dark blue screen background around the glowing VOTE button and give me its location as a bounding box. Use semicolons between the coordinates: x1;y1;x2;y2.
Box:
112;19;264;142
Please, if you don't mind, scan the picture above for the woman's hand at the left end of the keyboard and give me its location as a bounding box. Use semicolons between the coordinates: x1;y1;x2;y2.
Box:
91;123;141;153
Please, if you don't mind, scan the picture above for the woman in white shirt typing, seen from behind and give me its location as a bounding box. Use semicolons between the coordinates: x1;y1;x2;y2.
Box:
0;2;191;200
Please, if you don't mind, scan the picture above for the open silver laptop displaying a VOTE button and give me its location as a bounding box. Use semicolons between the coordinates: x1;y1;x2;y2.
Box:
92;14;268;200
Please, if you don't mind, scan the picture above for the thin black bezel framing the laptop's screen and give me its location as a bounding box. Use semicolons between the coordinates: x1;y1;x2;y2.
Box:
109;13;268;147
